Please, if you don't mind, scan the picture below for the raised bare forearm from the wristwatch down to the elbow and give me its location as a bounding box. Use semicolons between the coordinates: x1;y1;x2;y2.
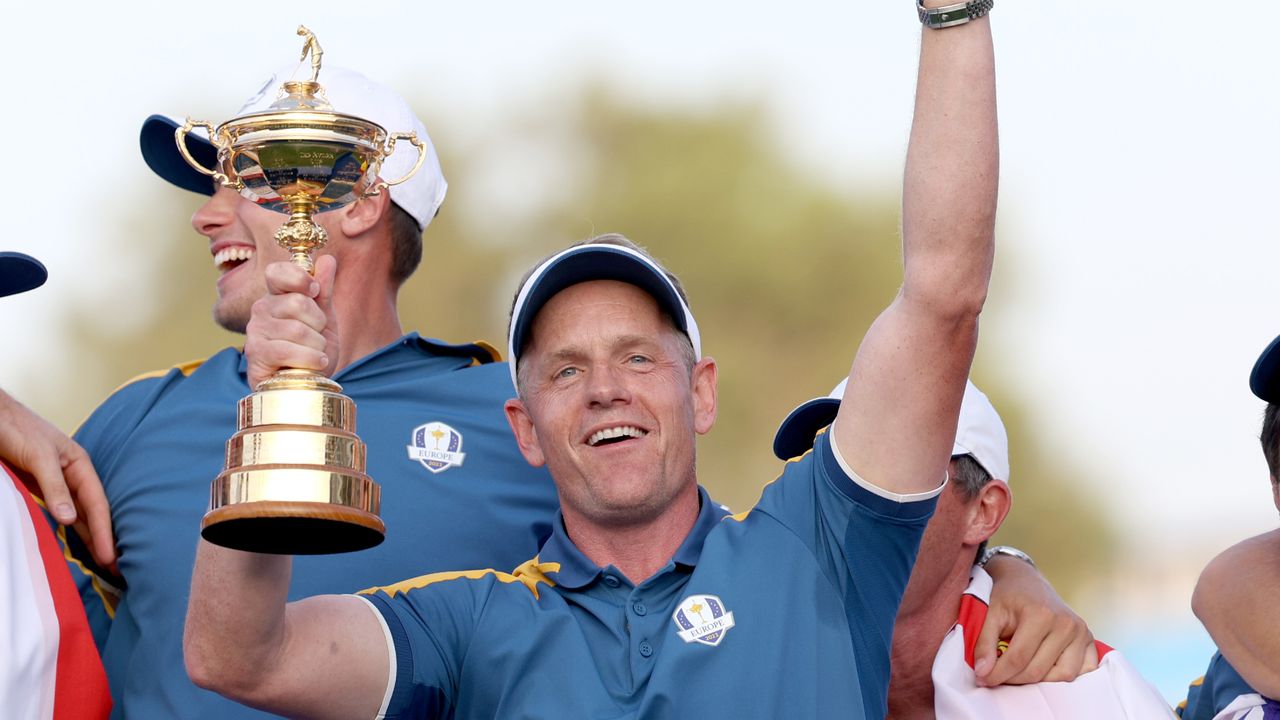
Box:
902;9;1000;314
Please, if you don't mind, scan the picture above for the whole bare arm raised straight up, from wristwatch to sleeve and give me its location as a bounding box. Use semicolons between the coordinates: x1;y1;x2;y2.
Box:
835;7;998;493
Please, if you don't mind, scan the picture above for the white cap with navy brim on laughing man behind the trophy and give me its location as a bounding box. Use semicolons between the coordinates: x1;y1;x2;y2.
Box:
140;64;448;229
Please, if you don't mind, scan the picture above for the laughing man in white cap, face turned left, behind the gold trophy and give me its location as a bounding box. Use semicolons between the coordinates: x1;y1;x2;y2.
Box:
52;32;556;719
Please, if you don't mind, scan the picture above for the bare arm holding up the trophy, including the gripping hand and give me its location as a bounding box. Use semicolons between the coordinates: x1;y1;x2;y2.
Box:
183;255;390;717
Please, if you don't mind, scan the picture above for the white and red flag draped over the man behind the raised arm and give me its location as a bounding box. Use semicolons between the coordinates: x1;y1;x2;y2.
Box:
933;566;1174;720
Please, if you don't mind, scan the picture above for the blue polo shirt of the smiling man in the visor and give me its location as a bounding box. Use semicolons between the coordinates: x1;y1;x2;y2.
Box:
361;434;941;720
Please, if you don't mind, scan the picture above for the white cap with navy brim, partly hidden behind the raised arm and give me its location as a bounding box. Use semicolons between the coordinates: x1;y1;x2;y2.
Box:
773;378;1009;483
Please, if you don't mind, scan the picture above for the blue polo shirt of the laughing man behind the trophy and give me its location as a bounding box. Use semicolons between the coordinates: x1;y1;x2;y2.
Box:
64;333;558;720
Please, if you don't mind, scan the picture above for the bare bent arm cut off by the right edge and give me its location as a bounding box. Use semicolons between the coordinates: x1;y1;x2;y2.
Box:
1192;530;1280;698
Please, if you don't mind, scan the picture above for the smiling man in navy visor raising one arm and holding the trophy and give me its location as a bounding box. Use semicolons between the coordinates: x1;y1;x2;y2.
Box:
184;7;998;720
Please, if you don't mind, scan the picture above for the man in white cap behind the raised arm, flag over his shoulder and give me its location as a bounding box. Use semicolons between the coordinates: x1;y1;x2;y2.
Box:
773;380;1171;720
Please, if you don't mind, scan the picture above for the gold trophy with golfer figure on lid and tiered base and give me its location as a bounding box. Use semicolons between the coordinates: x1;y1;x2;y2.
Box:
174;26;426;555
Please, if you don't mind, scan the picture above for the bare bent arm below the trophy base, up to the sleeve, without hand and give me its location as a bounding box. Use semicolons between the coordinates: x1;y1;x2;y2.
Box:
183;541;390;719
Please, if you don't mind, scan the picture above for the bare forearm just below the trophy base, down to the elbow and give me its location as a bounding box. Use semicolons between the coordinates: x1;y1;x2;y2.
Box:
183;541;292;700
